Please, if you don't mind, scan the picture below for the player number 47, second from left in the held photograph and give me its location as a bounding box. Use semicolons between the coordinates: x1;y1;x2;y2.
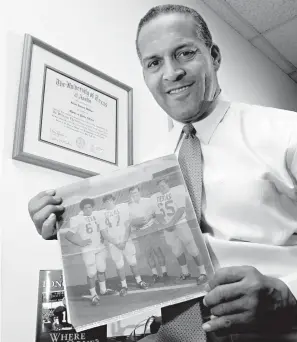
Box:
101;195;148;296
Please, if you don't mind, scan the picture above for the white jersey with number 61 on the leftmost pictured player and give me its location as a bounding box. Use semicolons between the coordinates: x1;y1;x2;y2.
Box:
70;211;104;251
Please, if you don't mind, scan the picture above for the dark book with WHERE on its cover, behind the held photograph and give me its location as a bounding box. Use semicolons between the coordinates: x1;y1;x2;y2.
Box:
35;270;107;342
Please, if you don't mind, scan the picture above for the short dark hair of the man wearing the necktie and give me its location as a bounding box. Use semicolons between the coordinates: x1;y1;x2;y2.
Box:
136;4;213;58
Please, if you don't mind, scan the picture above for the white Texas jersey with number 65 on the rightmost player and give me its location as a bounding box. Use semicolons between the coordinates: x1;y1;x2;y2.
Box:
153;185;186;223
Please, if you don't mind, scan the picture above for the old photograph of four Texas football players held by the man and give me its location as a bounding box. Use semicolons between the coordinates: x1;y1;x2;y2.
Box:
57;155;213;331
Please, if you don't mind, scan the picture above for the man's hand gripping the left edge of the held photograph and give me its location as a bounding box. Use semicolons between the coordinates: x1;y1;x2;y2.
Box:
28;190;65;240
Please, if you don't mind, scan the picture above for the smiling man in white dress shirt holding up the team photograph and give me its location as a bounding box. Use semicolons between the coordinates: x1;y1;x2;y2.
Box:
29;5;297;341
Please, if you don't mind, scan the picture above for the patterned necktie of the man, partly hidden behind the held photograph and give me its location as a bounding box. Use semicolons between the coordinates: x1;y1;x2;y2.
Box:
156;124;207;342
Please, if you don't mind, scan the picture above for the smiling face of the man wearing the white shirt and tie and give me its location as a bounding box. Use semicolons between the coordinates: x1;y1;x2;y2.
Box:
138;13;218;123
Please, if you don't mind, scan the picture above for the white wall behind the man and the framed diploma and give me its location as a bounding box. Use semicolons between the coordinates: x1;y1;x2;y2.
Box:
0;0;297;342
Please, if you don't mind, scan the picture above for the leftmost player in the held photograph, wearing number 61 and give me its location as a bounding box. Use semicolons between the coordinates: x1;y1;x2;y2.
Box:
65;198;115;305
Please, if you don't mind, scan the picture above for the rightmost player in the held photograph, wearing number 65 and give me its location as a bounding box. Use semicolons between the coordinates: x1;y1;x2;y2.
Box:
153;178;207;284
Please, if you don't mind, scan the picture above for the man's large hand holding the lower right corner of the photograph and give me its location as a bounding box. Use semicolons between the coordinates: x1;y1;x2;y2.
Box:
203;266;297;335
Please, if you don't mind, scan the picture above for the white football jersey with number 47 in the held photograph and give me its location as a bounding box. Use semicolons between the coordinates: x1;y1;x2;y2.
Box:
101;204;129;243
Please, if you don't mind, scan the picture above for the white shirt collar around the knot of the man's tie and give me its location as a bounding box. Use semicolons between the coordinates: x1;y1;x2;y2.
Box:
169;96;230;144
